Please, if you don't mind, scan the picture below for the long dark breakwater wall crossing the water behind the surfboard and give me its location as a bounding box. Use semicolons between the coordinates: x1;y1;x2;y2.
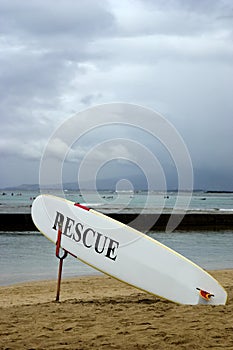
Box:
0;213;233;231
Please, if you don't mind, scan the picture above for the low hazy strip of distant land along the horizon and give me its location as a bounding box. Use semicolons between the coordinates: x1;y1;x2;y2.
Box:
0;182;233;193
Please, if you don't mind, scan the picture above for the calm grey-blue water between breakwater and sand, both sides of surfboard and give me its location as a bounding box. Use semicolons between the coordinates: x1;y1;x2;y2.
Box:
0;231;233;285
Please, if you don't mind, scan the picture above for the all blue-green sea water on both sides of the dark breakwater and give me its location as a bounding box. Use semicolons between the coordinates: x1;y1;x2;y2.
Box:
0;191;233;286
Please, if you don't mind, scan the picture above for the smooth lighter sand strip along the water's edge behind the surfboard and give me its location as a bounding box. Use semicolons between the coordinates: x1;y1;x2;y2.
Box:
0;268;230;308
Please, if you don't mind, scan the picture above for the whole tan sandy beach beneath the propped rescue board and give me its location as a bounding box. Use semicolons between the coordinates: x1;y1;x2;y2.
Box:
0;270;233;350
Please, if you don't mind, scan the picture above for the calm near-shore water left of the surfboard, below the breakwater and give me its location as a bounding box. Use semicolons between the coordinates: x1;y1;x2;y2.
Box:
0;232;97;285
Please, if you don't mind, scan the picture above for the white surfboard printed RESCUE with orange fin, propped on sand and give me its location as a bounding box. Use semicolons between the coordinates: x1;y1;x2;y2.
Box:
32;195;227;305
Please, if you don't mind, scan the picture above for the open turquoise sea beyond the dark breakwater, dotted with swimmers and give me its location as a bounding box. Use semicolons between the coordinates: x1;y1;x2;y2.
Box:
0;190;233;213
